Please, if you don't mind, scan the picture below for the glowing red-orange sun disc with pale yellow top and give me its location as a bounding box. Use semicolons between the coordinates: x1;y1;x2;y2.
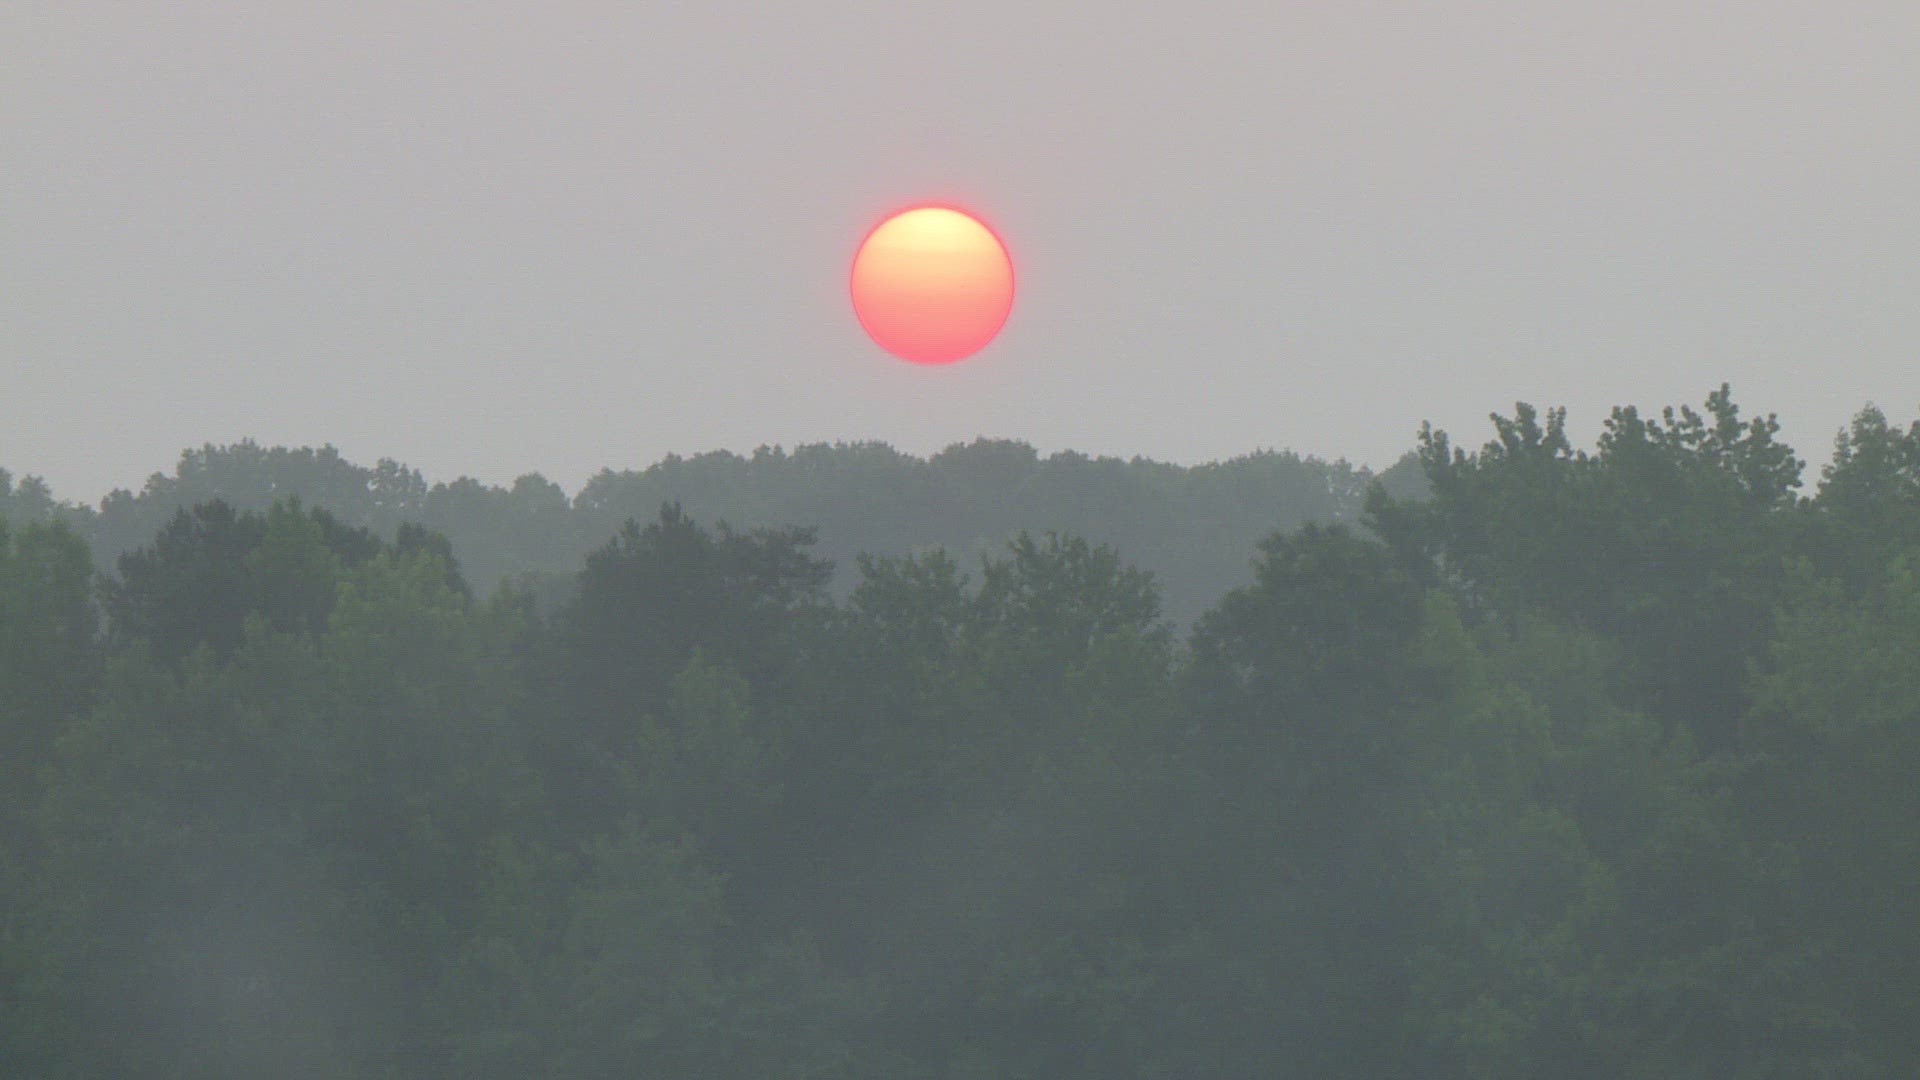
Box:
852;206;1014;363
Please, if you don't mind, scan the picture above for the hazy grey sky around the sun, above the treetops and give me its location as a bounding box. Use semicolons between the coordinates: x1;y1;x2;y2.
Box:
0;0;1920;500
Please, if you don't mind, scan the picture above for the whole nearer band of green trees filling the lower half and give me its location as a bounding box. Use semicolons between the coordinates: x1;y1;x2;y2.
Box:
0;388;1920;1080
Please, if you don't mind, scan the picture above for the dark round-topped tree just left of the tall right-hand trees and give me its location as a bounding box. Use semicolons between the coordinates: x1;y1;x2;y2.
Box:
1169;527;1427;1076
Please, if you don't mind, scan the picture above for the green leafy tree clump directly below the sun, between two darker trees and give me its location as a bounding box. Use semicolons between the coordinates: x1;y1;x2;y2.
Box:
735;534;1175;1076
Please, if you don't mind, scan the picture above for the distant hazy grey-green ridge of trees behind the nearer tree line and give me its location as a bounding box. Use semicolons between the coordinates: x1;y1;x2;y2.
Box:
0;438;1425;623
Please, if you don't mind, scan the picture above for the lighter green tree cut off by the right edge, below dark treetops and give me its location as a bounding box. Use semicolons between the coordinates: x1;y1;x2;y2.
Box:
1736;548;1920;1076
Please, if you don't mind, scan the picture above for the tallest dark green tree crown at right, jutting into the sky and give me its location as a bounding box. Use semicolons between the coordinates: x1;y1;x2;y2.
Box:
1367;386;1801;748
